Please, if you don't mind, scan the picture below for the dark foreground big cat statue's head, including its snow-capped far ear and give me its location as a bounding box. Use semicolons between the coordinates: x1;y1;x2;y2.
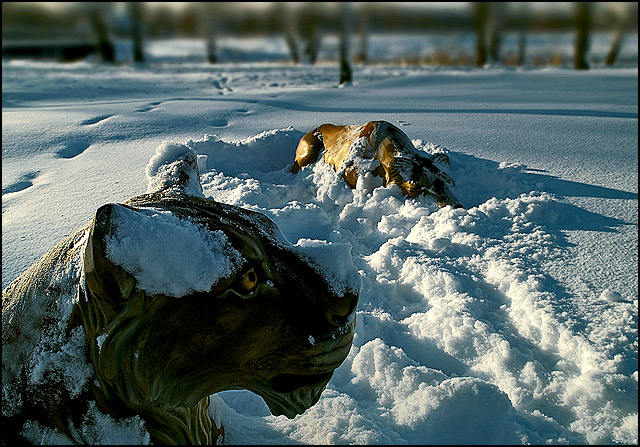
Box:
3;143;359;444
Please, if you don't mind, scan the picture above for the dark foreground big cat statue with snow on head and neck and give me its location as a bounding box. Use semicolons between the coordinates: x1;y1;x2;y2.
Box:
2;143;360;444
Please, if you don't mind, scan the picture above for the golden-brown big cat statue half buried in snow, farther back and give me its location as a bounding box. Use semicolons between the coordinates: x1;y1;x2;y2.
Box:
292;121;462;208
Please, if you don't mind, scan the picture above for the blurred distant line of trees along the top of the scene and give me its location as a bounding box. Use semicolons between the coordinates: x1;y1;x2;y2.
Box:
2;2;638;72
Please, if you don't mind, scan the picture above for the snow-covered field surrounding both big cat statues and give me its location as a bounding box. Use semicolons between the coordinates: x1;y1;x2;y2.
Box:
2;36;638;444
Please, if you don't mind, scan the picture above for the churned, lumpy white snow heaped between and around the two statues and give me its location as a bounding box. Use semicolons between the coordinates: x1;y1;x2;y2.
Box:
187;130;637;444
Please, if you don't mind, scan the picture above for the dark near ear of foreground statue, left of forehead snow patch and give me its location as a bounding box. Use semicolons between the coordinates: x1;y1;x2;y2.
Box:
84;204;135;311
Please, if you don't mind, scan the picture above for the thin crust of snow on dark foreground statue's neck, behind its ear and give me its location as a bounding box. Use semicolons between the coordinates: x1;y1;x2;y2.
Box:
2;231;93;416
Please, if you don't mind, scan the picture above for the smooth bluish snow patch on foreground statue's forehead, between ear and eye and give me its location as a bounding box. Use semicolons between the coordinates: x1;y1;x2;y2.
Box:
106;205;244;297
